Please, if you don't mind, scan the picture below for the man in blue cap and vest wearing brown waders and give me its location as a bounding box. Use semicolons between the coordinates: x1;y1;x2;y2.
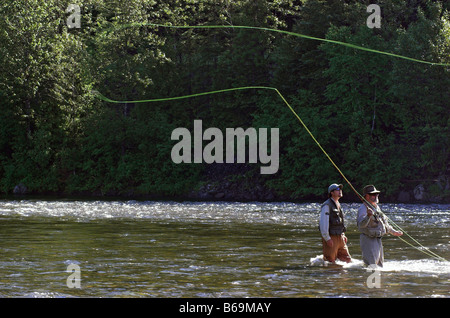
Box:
319;183;352;263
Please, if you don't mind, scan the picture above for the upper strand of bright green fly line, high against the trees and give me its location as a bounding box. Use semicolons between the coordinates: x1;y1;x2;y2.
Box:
100;22;450;66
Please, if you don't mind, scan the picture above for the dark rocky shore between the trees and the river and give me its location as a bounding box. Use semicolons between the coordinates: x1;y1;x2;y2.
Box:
8;164;450;204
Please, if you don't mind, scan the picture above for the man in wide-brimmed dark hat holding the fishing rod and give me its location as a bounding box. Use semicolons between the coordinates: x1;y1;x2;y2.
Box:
357;185;403;267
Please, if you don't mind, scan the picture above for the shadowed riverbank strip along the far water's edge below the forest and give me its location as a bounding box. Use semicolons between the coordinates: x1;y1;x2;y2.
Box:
7;164;450;204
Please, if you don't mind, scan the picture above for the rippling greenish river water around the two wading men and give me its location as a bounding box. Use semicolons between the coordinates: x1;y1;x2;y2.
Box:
0;200;450;297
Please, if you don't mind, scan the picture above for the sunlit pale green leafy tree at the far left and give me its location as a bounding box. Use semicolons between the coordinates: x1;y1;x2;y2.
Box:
0;0;86;192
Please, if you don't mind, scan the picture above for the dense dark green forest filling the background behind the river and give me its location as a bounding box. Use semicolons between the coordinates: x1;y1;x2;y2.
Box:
0;0;450;199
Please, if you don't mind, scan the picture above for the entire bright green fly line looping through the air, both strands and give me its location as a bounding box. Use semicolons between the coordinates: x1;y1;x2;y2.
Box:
93;23;450;261
